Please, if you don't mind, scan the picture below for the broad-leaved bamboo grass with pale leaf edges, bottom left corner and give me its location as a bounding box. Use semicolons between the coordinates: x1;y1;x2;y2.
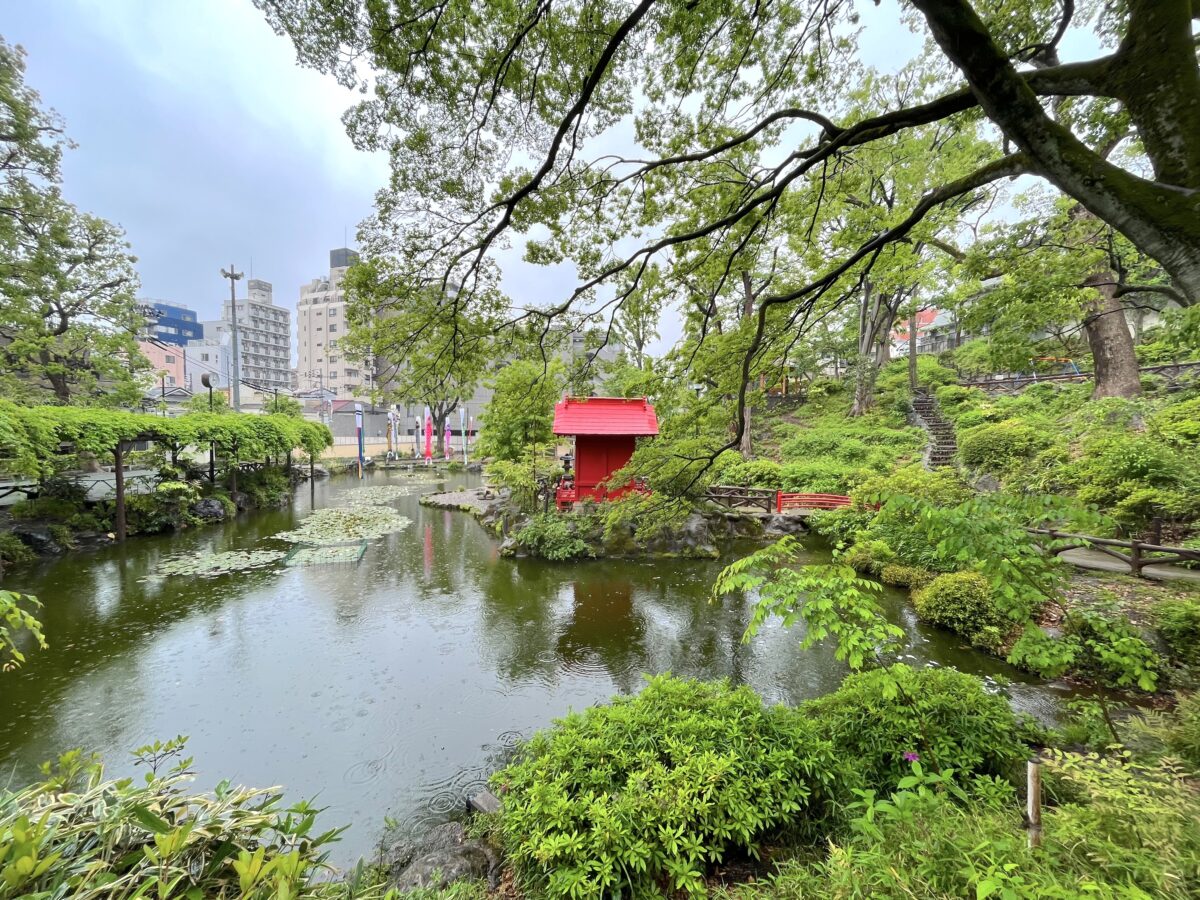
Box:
0;739;385;900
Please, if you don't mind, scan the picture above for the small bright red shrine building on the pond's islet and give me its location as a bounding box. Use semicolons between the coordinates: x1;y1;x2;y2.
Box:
554;397;659;509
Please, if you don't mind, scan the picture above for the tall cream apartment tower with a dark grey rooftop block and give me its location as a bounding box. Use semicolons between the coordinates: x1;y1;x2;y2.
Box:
296;247;371;400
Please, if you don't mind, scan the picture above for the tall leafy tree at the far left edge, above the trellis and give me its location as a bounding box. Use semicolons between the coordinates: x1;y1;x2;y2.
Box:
0;40;150;404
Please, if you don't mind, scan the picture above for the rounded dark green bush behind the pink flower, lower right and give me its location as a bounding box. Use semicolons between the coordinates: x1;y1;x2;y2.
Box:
800;664;1025;788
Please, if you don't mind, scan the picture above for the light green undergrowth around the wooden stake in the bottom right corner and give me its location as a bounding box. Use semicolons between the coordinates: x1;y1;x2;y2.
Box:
721;754;1200;900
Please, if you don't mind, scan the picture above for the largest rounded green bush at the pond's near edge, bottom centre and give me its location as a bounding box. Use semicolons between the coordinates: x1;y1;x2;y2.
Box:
492;676;854;898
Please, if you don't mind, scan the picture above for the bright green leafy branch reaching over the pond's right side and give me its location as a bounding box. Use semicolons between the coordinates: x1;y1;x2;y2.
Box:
713;535;904;671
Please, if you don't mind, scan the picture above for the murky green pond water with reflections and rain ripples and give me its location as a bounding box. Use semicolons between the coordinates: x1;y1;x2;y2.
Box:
0;472;1064;864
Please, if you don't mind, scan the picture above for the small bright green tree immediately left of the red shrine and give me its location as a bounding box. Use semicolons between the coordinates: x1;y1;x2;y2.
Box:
475;359;566;461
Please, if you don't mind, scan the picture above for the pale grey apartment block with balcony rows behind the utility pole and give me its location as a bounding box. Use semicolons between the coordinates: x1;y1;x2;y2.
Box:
202;278;292;390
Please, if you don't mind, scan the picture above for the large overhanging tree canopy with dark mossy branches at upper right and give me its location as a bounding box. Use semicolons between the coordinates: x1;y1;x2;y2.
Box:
256;0;1200;451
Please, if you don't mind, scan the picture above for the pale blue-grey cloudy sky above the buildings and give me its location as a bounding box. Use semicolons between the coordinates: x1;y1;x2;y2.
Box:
0;0;919;360
